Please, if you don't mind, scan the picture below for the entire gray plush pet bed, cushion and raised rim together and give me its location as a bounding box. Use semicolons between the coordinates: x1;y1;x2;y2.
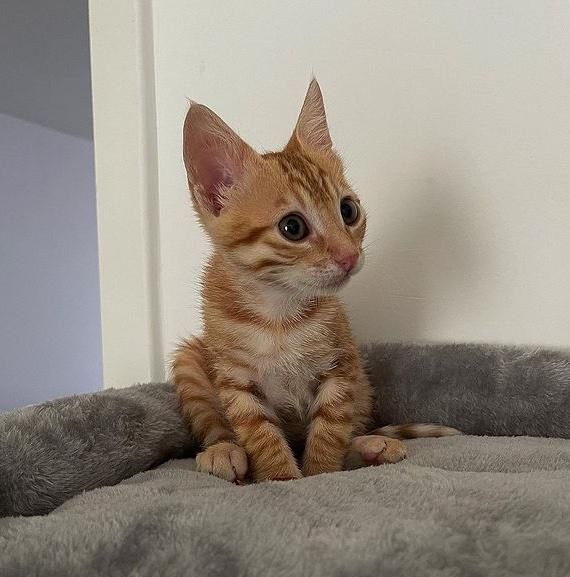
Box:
0;345;570;577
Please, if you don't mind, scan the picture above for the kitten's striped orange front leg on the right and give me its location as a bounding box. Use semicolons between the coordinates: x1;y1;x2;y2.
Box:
303;376;355;476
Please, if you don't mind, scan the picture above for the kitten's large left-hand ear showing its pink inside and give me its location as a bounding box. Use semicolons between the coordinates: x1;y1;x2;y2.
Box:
183;102;258;216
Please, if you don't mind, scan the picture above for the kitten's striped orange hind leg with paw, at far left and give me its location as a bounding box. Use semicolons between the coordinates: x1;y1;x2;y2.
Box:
171;337;247;482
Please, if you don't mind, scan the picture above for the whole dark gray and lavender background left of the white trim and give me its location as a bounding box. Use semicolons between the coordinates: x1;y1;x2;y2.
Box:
0;0;102;412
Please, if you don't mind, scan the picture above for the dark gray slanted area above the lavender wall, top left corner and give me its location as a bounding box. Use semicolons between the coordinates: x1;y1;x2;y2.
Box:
0;0;93;140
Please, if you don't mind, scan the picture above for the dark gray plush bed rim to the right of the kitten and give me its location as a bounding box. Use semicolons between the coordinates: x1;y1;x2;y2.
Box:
363;344;570;439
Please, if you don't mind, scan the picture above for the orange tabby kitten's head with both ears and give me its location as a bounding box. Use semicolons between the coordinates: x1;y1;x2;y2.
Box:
184;79;366;295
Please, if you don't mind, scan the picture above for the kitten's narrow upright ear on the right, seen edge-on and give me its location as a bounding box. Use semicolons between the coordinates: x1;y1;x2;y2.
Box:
287;78;332;151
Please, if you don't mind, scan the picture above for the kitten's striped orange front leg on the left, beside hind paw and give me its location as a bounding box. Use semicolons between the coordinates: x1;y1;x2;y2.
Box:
218;379;302;481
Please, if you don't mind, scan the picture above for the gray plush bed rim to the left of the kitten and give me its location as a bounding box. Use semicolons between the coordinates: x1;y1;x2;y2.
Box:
0;384;192;517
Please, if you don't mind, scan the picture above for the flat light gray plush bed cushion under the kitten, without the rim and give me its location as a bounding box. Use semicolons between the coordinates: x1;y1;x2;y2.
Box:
0;437;570;577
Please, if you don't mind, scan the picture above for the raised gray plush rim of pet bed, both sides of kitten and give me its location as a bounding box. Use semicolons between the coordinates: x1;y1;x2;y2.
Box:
0;344;570;516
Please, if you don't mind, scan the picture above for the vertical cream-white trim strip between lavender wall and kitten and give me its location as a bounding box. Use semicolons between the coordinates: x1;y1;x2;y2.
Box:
89;0;164;387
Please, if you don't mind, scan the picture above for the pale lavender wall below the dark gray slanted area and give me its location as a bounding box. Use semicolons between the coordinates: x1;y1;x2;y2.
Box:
0;114;102;412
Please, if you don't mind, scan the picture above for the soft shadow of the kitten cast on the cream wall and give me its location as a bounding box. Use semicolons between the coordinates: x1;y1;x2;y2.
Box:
345;162;482;341
